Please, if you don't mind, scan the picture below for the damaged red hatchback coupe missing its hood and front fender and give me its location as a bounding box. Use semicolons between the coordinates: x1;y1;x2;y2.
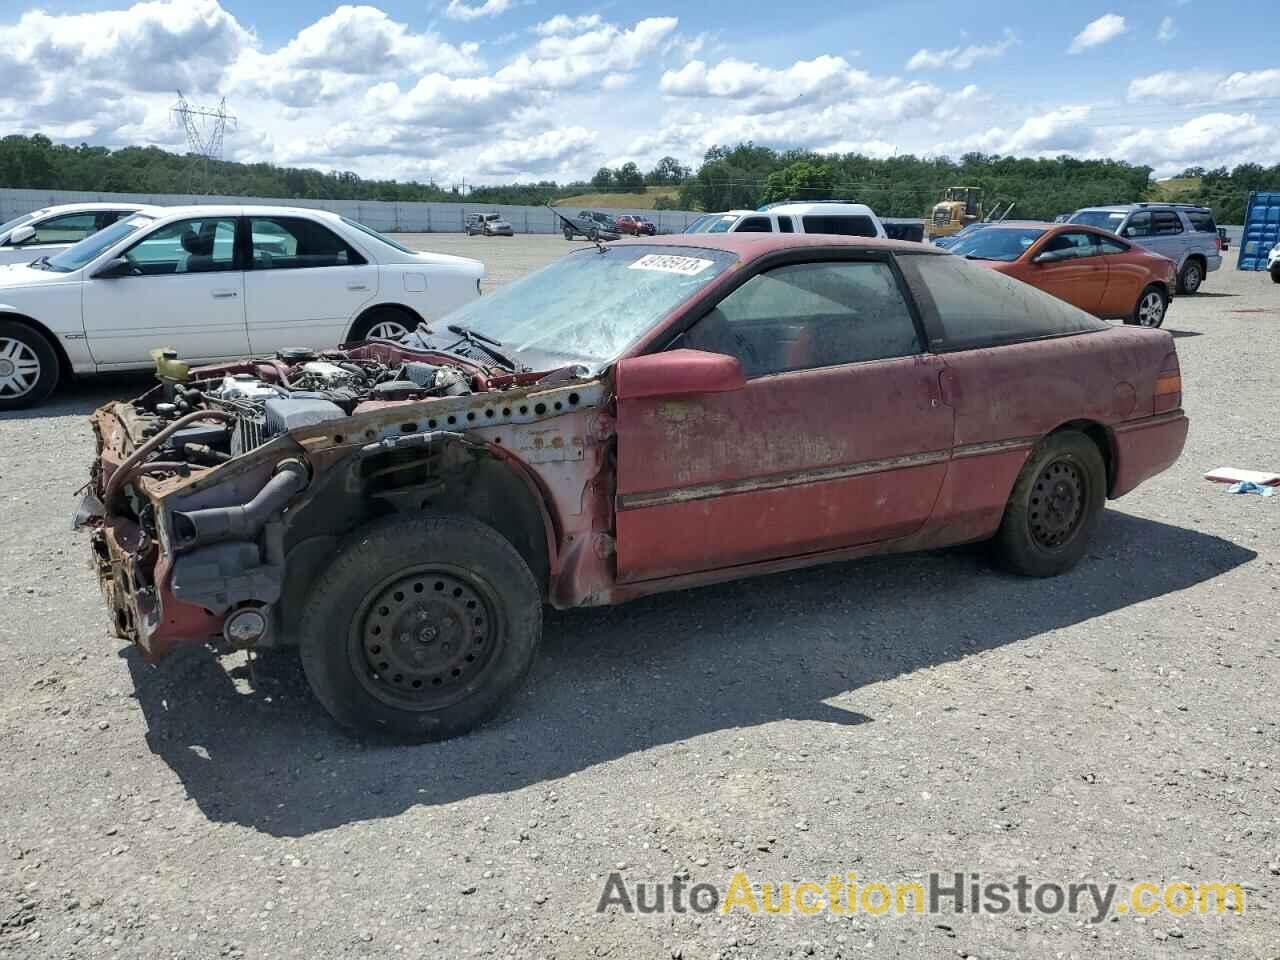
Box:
77;234;1187;740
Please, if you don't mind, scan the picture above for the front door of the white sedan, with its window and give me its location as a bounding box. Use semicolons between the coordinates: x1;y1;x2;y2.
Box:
82;216;248;369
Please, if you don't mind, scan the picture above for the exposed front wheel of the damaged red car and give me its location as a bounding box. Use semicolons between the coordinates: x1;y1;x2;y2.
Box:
300;515;543;742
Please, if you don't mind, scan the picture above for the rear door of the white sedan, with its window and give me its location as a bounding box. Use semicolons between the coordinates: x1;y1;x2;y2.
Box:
244;215;378;353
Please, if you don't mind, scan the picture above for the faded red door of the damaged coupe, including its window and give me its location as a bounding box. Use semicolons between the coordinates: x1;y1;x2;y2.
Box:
616;257;952;582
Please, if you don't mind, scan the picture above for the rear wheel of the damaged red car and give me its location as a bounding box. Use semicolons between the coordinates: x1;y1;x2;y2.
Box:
992;430;1107;577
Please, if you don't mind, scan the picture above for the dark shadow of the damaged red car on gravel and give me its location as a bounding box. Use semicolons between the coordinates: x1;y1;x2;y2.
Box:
122;511;1257;836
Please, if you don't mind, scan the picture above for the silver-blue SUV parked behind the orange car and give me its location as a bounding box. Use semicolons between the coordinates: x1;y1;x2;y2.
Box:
1068;204;1222;293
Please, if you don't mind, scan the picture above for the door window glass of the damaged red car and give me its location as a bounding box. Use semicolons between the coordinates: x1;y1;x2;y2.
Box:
678;261;923;376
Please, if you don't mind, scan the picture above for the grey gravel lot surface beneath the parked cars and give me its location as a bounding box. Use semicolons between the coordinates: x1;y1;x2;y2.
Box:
0;236;1280;960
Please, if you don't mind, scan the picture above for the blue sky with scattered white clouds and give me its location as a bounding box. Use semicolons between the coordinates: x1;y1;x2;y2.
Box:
0;0;1280;183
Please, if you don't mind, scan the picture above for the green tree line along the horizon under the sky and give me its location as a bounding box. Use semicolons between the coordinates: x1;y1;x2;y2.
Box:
0;133;1280;223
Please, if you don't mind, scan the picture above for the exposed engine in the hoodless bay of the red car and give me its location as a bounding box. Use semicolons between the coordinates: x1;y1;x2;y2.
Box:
142;349;471;466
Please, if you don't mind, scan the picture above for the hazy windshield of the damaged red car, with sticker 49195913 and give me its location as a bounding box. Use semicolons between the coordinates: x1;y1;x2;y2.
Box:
422;244;736;365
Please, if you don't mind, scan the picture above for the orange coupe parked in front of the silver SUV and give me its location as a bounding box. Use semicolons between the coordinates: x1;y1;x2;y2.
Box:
951;223;1176;326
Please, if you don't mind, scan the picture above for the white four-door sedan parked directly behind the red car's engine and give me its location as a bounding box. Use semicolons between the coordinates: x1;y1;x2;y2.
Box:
0;206;484;410
